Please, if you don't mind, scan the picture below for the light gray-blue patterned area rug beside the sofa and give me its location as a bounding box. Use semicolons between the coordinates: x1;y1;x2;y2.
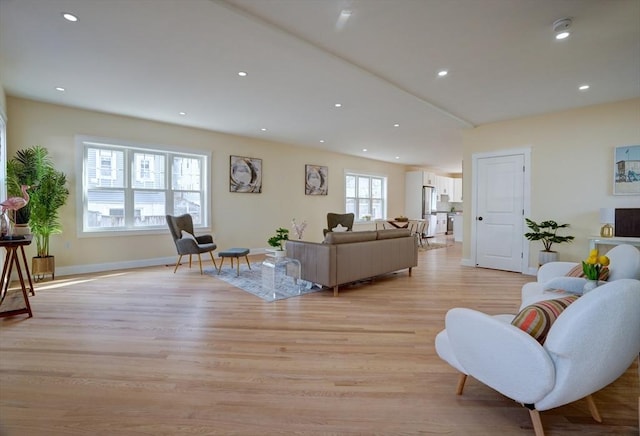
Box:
204;263;322;301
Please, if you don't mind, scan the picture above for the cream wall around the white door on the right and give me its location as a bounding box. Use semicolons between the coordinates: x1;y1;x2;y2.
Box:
463;99;640;267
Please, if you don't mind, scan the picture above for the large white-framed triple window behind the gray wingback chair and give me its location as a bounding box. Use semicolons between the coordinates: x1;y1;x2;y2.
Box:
78;138;210;233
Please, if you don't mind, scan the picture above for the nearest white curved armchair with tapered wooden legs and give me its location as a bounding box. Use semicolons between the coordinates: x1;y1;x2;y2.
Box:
435;279;640;436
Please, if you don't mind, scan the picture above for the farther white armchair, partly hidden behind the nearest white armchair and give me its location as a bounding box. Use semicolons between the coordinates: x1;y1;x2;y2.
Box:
520;244;640;309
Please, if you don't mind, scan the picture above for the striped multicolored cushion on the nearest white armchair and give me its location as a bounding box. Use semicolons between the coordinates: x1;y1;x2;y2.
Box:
511;295;578;344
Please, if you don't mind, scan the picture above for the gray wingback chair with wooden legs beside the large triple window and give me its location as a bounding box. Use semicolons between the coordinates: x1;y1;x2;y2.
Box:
166;214;218;274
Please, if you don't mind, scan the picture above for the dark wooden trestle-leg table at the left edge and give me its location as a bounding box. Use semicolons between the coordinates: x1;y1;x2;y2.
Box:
0;235;35;318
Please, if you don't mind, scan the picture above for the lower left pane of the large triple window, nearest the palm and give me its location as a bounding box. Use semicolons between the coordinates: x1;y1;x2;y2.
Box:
87;189;125;229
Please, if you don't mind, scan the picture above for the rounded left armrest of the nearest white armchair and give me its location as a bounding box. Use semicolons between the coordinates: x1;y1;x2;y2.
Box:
445;308;555;404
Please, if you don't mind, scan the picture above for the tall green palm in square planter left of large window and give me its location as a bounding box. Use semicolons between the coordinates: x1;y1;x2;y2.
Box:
7;146;69;279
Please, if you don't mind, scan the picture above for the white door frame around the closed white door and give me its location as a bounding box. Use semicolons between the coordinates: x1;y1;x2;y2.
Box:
469;147;535;275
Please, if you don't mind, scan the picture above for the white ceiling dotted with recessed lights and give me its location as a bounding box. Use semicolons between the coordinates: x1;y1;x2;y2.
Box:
0;0;640;173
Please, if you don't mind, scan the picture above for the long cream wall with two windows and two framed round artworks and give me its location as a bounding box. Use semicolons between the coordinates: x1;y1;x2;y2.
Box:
7;96;405;275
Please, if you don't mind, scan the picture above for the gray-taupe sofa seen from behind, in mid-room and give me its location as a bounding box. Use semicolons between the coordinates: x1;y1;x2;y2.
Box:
286;229;418;296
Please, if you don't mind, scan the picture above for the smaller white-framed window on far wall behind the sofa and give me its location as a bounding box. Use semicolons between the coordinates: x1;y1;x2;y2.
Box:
345;173;387;221
